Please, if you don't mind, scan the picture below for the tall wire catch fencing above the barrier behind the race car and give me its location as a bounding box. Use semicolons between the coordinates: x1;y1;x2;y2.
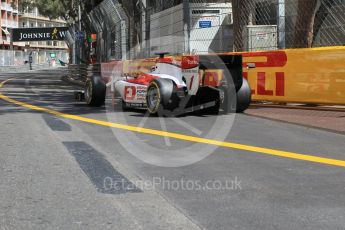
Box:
84;0;345;62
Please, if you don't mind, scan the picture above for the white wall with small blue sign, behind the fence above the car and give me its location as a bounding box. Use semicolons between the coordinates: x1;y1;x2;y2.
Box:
150;3;233;54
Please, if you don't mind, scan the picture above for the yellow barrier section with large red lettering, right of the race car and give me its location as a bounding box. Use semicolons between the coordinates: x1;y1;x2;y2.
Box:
241;46;345;105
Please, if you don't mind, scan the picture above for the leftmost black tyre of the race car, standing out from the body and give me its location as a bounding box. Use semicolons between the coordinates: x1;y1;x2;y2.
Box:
85;76;106;107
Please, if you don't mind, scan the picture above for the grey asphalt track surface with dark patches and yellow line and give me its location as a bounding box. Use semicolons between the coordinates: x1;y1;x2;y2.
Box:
0;69;345;230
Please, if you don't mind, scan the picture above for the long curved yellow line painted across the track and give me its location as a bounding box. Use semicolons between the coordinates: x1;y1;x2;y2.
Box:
0;79;345;167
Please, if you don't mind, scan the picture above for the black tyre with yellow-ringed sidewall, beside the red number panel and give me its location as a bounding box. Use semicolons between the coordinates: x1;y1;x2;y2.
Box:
146;78;175;116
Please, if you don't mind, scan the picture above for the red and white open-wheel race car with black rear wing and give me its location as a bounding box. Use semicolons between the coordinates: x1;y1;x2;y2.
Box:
85;53;251;116
